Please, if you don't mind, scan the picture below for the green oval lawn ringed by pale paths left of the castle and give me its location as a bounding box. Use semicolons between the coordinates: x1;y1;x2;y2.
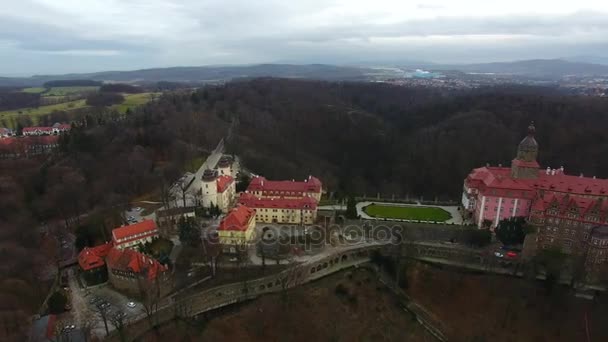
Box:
363;204;452;222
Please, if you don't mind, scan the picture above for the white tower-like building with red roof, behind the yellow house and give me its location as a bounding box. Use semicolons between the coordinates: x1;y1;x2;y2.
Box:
201;169;236;213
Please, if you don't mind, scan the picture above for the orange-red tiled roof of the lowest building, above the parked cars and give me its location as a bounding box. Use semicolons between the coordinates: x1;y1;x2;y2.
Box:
106;248;168;280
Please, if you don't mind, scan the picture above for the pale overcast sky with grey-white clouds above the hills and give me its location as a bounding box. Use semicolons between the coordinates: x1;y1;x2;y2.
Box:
0;0;608;76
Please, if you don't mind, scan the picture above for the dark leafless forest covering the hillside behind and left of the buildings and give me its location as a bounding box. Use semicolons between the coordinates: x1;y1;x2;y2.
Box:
0;79;608;340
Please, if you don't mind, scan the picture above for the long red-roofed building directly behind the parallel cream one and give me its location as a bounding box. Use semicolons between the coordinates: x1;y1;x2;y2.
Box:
247;176;323;202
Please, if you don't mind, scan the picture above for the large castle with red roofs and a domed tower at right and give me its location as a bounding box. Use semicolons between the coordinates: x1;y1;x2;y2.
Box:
462;124;608;276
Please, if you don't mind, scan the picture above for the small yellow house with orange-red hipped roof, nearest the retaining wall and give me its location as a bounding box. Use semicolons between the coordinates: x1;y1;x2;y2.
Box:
217;205;256;253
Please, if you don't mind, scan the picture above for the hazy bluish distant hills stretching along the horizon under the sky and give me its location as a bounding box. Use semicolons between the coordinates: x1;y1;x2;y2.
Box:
0;59;608;87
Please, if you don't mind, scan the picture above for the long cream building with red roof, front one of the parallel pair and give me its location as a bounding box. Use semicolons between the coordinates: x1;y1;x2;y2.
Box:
238;192;317;224
